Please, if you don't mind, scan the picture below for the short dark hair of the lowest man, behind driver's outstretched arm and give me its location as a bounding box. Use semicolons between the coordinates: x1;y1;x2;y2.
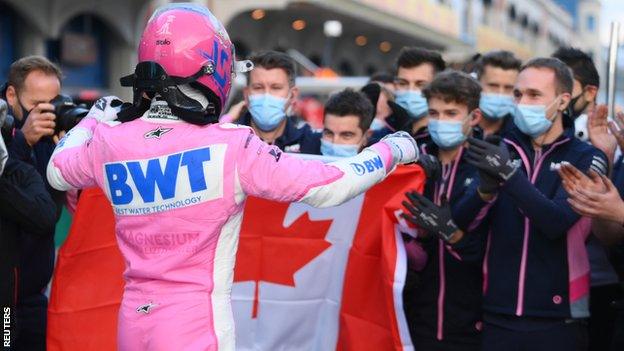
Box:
324;88;375;132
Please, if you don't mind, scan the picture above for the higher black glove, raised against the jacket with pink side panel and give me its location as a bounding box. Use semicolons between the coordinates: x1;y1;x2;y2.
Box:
466;137;518;183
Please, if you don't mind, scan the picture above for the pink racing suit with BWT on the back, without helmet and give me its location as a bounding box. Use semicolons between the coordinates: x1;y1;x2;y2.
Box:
48;102;394;350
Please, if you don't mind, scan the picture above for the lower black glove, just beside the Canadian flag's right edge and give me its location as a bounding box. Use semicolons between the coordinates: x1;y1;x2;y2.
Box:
402;191;458;242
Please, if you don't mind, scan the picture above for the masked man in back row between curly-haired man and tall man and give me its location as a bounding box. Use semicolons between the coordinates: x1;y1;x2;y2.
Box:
475;51;522;138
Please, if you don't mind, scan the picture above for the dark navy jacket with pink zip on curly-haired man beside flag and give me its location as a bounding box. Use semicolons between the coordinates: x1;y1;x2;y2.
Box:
405;143;482;346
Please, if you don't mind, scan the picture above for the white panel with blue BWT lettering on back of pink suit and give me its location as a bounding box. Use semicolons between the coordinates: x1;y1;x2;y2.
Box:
104;144;227;216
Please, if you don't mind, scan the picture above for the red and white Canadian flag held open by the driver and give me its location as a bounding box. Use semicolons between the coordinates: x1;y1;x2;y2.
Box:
48;166;425;351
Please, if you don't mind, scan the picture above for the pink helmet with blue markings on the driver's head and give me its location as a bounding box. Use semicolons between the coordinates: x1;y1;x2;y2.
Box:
120;3;252;124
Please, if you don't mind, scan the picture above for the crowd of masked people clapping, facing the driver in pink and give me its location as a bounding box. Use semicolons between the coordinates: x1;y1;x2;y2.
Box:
224;47;624;350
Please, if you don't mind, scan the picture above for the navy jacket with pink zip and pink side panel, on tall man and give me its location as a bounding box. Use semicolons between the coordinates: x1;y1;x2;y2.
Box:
454;128;607;318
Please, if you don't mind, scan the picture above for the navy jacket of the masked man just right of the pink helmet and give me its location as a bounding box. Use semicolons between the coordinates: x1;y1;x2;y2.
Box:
236;111;321;155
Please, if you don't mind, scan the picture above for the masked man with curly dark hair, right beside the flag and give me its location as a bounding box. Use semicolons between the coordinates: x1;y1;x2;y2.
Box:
405;71;482;350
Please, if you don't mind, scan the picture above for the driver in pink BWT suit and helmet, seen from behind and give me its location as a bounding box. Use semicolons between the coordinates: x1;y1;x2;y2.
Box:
48;4;418;350
